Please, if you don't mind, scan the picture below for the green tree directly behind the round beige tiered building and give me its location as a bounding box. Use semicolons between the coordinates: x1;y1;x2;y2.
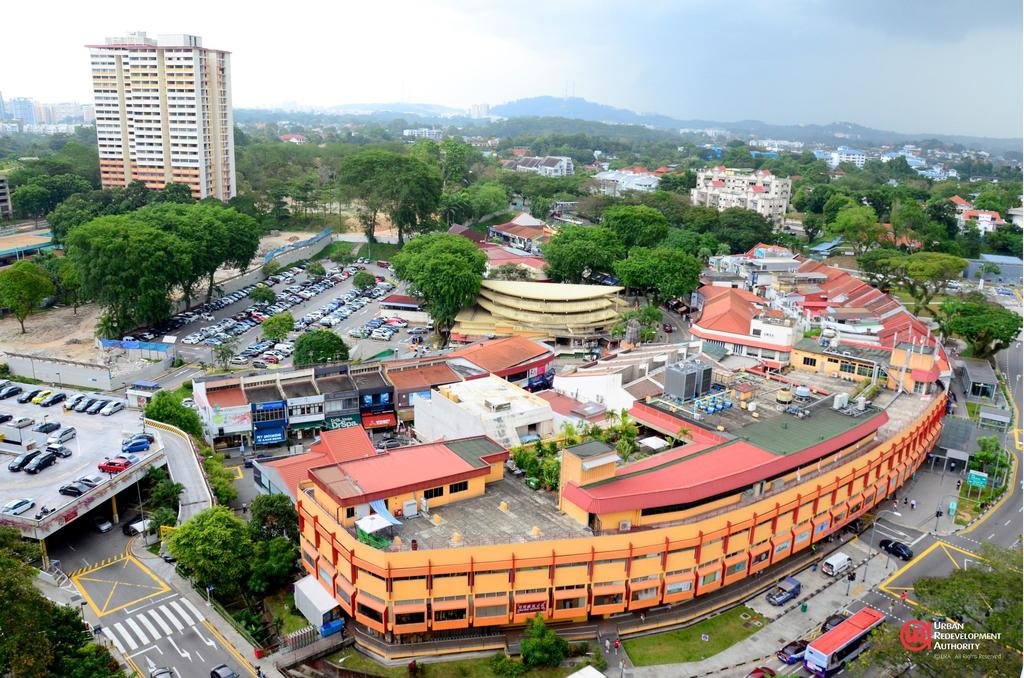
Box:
541;225;626;283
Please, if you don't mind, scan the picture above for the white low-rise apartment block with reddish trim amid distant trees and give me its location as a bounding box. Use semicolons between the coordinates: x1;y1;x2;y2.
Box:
690;166;793;223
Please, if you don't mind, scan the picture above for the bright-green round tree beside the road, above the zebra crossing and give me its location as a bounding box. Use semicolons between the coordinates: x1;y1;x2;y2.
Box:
168;506;253;596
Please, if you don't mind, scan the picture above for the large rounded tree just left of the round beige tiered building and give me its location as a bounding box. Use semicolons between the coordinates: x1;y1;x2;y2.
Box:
391;234;486;332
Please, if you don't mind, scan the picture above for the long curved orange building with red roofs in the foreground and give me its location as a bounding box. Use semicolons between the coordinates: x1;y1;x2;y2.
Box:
297;395;945;637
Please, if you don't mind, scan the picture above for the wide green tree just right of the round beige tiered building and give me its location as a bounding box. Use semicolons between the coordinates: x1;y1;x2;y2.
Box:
614;247;701;304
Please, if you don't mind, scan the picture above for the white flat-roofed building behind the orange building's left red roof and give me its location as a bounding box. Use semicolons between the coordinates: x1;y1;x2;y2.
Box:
413;375;555;448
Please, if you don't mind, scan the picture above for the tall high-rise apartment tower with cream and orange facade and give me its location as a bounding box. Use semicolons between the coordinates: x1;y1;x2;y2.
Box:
87;33;236;200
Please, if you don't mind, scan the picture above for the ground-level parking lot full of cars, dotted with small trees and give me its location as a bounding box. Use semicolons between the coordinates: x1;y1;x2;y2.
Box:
146;262;423;368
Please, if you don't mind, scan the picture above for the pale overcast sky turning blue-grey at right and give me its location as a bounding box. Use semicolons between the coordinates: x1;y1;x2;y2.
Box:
0;0;1024;137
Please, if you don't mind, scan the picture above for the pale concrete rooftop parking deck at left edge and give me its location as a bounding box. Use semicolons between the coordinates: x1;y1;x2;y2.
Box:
0;382;153;518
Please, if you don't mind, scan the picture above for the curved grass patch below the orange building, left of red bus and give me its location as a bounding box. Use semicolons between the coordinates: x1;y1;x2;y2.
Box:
624;605;765;666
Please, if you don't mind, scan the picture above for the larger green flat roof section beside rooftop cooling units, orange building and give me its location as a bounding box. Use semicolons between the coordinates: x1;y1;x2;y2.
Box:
733;404;881;455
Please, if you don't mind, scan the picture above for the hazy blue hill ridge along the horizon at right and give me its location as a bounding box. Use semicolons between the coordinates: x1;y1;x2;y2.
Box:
490;96;1021;153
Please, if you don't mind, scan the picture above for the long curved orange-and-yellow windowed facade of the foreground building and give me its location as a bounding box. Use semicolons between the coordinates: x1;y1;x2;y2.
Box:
298;397;945;634
